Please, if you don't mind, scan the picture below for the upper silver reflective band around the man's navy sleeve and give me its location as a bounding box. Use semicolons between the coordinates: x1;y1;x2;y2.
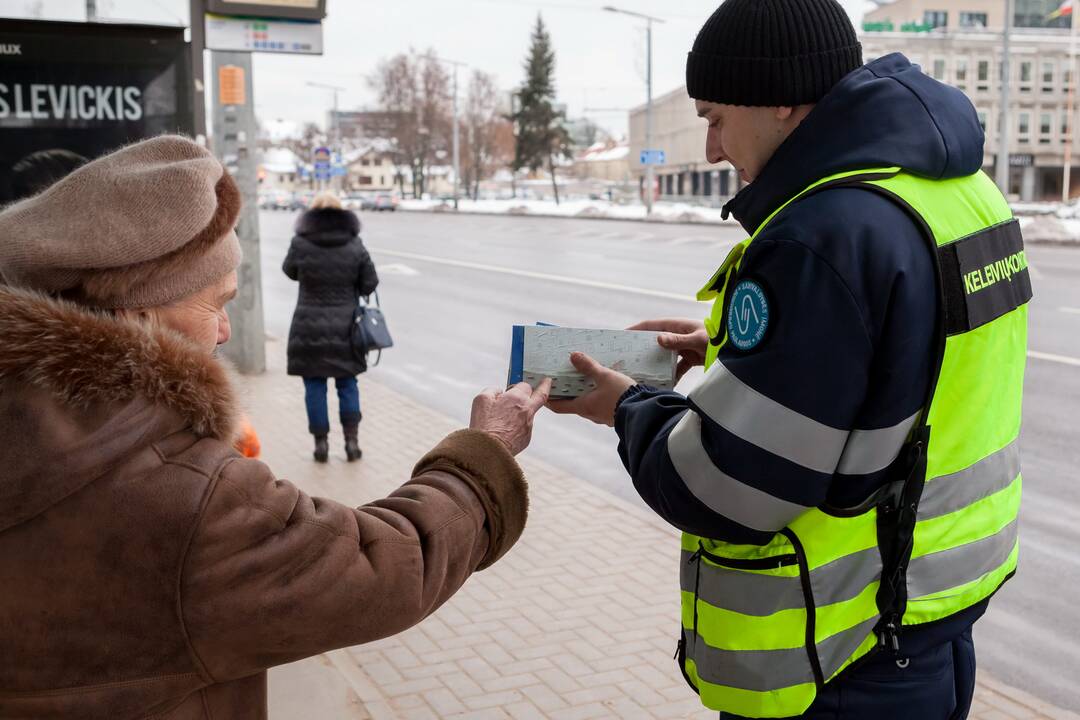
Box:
690;361;848;475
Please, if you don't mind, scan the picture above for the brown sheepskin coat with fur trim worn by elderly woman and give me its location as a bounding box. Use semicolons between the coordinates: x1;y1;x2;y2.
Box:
0;286;527;720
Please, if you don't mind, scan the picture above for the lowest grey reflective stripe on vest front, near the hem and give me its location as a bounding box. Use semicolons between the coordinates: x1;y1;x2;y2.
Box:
684;615;878;692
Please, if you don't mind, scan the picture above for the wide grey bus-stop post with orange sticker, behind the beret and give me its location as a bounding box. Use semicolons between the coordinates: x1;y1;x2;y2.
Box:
212;52;267;373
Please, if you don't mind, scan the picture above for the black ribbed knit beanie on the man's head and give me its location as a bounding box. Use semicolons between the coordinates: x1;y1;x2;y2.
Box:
686;0;863;107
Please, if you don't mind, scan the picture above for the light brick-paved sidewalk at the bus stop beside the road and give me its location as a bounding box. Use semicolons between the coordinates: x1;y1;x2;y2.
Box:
243;342;1080;720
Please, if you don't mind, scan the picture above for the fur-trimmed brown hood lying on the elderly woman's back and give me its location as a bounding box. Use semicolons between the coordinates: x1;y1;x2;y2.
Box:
0;286;237;531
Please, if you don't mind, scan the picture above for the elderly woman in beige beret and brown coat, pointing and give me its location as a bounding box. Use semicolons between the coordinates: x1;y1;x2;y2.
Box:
0;137;544;719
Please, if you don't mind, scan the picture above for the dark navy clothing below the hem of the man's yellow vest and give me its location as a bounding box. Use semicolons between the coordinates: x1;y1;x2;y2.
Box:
720;627;975;720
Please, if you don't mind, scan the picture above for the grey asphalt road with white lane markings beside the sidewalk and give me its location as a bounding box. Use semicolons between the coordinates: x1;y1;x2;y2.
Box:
254;207;1080;710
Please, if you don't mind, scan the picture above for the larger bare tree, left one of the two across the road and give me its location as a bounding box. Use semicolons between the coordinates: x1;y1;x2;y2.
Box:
370;50;450;196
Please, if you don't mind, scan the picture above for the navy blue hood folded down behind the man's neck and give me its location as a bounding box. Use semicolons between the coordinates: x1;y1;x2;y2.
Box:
724;53;983;233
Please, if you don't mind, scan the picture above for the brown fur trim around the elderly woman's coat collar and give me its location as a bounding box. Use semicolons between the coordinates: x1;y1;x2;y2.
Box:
0;286;237;441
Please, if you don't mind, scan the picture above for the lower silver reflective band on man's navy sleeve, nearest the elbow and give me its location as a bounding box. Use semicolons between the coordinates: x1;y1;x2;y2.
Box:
667;410;809;532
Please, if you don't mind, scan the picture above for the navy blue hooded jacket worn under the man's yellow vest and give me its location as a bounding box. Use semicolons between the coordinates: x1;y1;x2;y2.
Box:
616;54;983;651
